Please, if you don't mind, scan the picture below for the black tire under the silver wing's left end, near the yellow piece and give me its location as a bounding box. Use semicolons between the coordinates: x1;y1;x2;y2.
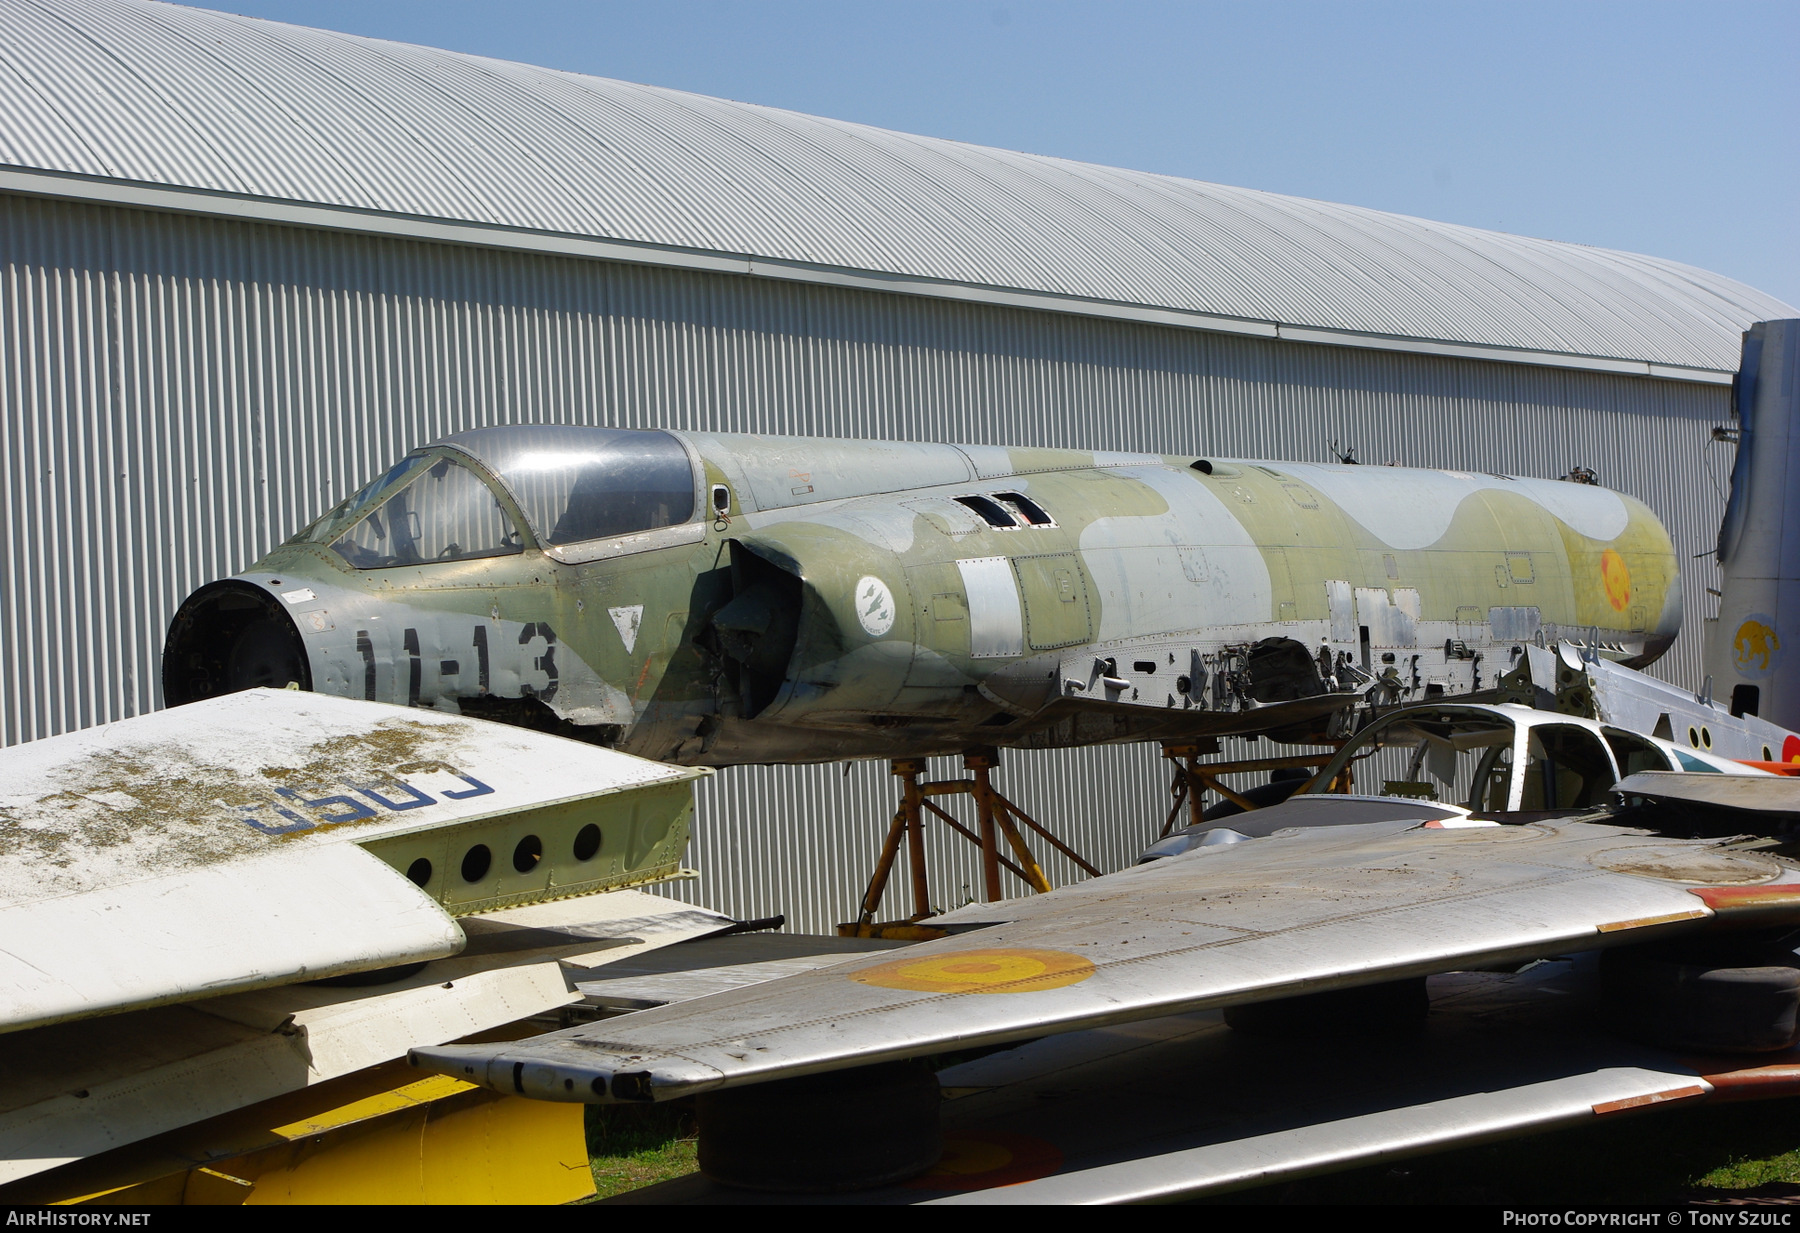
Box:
698;1062;943;1193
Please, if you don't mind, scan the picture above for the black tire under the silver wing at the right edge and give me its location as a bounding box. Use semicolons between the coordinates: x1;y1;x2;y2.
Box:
1600;947;1800;1053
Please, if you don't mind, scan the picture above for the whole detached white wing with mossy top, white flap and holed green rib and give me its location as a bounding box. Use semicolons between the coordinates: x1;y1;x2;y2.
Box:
0;689;709;1031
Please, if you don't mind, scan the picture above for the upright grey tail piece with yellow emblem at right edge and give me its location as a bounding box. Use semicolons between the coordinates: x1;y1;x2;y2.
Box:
1706;320;1800;734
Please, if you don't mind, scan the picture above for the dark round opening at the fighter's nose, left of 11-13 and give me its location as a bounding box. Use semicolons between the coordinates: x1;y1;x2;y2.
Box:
162;580;313;706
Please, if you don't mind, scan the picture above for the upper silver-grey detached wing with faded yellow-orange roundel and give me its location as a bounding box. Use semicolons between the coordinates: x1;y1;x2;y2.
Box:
412;819;1800;1102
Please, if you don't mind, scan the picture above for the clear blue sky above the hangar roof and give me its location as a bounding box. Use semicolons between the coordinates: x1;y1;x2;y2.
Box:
212;0;1800;304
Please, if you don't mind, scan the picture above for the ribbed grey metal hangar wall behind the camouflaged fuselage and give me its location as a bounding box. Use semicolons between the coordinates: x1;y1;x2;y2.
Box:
0;196;1730;929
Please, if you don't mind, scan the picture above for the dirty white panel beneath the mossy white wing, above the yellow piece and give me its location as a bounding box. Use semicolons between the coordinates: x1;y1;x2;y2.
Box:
0;891;729;1183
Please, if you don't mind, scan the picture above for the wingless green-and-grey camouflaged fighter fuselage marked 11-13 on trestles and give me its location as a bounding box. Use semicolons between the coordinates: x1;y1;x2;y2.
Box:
164;425;1681;765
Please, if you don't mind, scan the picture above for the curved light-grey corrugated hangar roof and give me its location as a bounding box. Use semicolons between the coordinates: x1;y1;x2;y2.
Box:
0;0;1796;382
